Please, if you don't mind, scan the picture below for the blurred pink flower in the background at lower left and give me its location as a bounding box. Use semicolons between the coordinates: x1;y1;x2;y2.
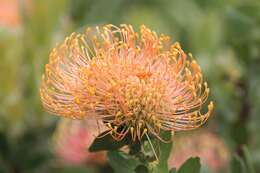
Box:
54;119;105;165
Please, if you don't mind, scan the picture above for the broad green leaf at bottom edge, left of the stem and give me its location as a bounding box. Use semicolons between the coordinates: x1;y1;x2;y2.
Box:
107;151;141;173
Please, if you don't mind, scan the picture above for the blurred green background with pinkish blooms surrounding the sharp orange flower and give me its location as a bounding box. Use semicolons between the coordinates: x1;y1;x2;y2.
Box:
0;0;260;173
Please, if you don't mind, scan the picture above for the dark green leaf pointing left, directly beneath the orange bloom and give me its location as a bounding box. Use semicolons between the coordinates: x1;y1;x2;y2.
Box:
89;131;128;152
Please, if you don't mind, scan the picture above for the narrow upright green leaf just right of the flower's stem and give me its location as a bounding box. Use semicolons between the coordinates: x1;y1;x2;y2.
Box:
154;131;172;173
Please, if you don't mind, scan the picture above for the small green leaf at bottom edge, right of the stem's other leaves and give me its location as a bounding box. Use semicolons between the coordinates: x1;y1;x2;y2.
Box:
177;157;201;173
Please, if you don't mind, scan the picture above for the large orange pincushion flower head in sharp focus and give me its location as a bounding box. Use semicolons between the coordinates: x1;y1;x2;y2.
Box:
40;25;213;140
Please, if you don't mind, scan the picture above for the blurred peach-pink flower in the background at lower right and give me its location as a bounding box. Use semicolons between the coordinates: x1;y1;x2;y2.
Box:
168;130;230;172
